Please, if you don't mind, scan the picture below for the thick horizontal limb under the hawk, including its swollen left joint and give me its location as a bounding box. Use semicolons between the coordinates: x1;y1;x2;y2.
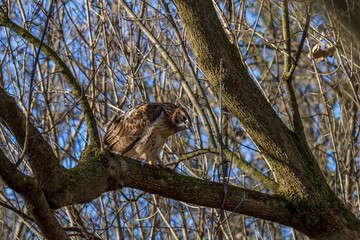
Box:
48;148;292;230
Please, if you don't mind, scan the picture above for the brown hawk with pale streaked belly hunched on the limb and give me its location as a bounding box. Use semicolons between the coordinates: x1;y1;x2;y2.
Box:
103;103;191;167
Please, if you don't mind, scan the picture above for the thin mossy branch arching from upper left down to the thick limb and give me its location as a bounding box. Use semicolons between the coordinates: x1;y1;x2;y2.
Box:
0;7;100;146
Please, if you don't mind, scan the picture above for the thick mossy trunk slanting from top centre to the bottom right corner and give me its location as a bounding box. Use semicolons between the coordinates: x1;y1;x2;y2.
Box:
175;0;360;239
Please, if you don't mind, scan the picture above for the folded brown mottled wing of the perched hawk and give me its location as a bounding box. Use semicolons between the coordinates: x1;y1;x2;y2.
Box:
103;103;163;155
